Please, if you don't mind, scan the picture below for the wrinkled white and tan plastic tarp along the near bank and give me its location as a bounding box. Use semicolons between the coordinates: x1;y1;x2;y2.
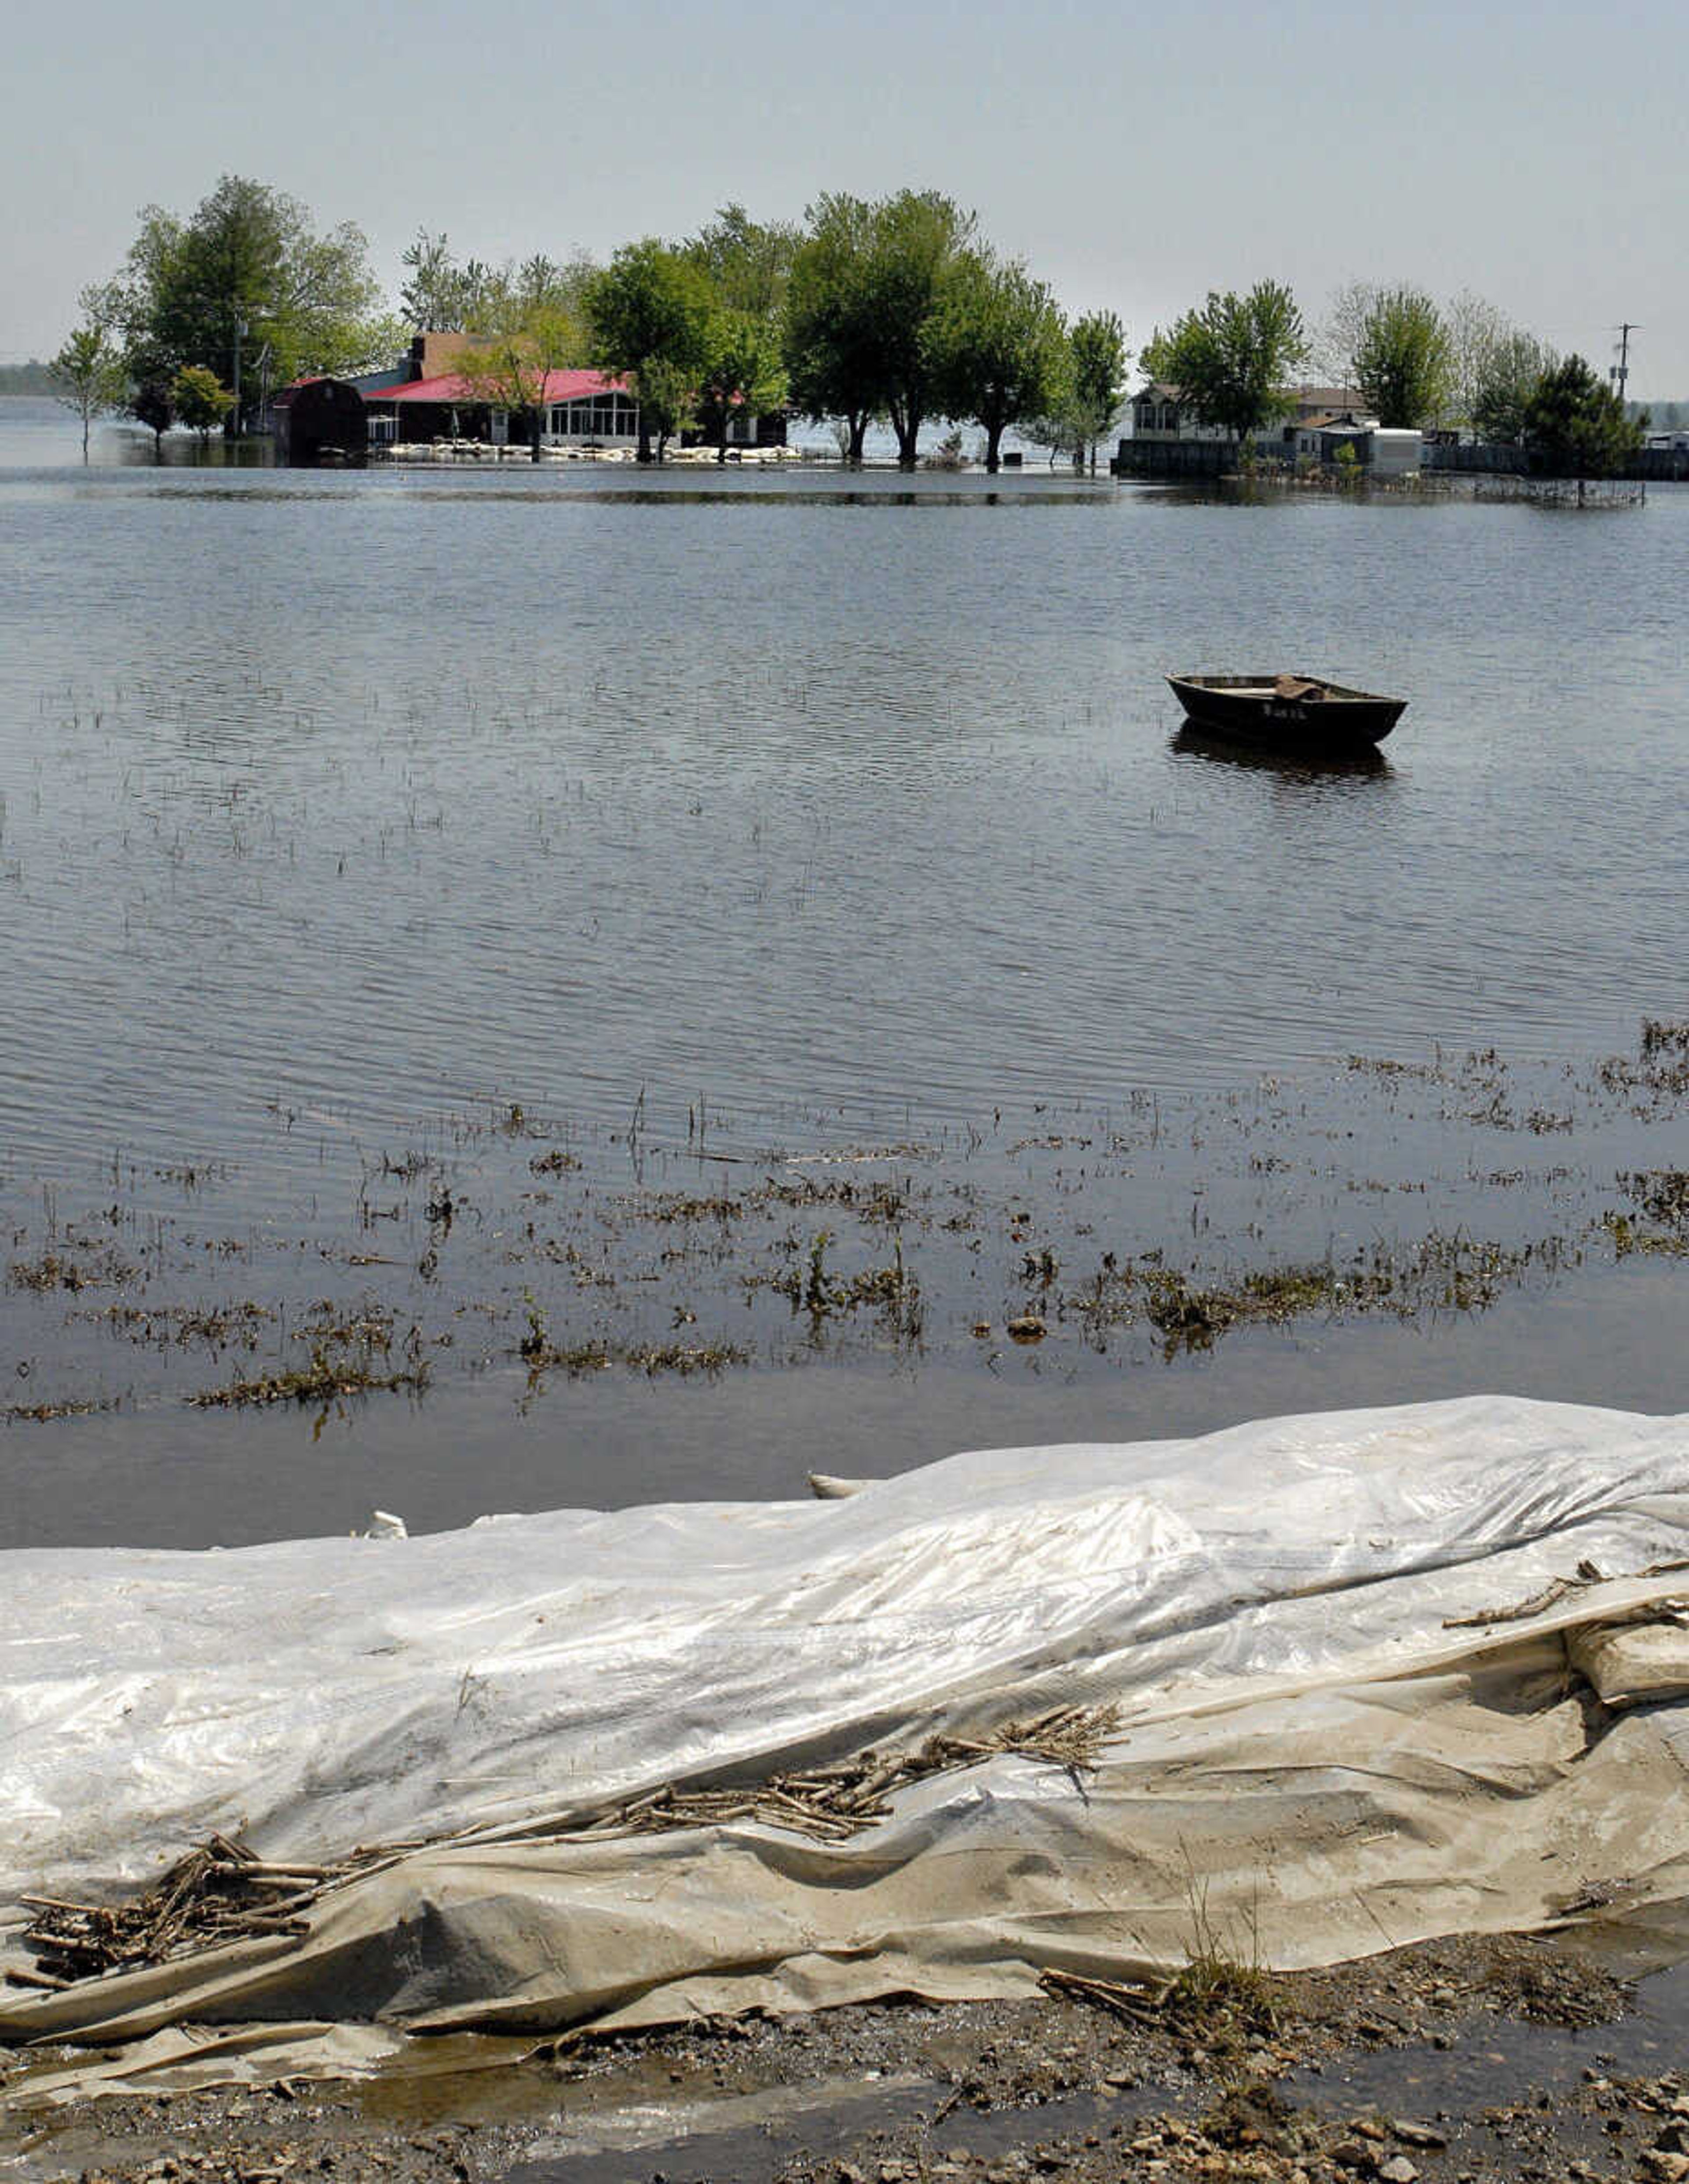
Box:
0;1398;1689;2073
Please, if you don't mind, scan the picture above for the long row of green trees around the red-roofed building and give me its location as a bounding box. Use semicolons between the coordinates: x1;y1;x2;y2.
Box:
55;175;1127;470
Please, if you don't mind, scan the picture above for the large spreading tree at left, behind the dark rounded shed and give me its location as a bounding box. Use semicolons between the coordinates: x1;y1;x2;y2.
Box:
94;175;378;430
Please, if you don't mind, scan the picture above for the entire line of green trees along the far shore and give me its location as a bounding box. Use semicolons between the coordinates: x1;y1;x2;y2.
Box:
50;175;1648;470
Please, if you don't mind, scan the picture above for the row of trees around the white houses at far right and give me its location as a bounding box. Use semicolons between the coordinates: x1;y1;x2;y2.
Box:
1143;282;1648;474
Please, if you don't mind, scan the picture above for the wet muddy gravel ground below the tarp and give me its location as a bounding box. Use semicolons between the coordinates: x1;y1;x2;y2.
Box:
0;1937;1689;2184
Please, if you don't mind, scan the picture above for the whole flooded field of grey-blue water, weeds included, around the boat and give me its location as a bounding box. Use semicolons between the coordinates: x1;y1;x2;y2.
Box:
0;406;1689;1544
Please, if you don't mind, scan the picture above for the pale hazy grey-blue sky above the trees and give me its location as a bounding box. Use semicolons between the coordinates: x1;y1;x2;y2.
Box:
0;0;1689;400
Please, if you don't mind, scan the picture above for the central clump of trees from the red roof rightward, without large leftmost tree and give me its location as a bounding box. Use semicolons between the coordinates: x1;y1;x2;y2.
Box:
400;190;1127;470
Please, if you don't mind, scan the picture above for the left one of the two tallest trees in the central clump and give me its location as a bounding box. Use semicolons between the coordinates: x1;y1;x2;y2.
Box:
782;194;885;465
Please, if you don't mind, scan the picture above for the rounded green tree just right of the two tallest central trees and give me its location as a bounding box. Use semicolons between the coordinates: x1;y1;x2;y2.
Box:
926;249;1068;472
